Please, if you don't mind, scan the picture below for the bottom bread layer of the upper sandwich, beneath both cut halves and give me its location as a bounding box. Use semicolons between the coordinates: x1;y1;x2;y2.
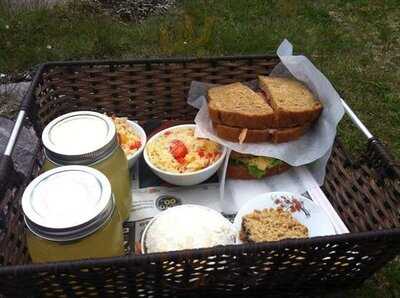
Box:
213;123;311;143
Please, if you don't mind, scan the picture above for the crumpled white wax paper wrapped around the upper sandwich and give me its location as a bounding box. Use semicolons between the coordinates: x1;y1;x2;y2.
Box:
188;40;344;185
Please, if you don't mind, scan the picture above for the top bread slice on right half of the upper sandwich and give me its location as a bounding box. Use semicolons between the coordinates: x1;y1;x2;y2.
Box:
258;76;322;127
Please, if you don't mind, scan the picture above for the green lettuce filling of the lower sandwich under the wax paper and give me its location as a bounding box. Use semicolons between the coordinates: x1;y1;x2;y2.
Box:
229;153;283;178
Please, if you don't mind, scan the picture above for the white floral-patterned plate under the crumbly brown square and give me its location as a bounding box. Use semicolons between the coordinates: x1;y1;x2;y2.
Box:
233;192;336;243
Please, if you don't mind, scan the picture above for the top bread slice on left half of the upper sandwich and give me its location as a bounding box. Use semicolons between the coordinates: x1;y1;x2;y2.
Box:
208;83;276;129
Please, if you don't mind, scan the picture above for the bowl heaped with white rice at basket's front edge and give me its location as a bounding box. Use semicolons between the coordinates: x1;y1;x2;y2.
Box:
141;204;236;253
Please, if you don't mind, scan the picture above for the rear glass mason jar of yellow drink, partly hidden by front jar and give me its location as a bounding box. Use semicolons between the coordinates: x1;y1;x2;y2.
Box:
42;111;132;220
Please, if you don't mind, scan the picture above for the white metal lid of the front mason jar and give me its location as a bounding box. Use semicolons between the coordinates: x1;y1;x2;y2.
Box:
22;166;115;241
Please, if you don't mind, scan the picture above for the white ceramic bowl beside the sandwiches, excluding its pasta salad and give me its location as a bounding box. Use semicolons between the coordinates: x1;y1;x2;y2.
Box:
143;124;226;186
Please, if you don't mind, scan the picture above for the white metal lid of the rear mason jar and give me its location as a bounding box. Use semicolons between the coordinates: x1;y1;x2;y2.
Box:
42;111;118;165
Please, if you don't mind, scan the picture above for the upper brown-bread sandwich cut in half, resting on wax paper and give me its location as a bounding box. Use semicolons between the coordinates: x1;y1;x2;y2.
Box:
207;76;322;143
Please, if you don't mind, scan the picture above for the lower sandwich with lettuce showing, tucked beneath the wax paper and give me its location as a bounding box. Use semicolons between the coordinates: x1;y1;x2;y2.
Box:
227;151;290;180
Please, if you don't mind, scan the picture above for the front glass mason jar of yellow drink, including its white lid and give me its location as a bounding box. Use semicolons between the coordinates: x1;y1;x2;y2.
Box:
22;166;124;263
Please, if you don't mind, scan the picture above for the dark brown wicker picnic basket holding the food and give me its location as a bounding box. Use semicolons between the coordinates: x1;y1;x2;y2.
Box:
0;56;400;297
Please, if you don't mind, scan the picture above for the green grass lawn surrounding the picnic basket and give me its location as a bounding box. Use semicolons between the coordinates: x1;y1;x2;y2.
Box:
0;0;400;297
